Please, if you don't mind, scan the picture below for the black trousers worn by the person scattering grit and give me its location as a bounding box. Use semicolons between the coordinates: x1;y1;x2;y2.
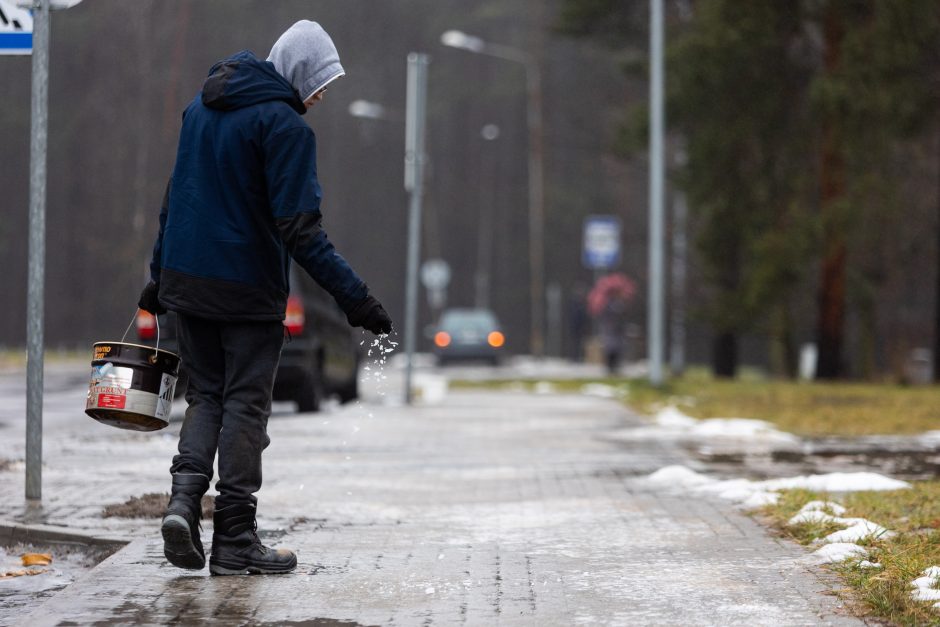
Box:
170;314;284;508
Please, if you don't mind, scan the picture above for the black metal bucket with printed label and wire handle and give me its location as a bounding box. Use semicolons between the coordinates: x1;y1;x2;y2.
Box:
85;314;180;431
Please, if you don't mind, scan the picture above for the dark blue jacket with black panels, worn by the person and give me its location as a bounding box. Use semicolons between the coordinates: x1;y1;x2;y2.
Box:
150;51;368;320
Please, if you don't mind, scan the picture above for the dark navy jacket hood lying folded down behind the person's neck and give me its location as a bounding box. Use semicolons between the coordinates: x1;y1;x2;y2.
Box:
202;50;307;115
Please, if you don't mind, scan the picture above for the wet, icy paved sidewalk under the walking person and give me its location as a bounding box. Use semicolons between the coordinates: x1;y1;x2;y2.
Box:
0;370;862;626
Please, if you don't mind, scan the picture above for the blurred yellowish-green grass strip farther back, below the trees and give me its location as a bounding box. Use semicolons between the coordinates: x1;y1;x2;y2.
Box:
457;371;940;436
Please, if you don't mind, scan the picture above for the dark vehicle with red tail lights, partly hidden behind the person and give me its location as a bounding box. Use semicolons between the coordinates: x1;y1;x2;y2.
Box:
137;267;361;412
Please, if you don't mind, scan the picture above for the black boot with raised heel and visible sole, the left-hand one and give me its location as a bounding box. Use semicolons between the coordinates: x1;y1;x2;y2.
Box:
160;474;209;570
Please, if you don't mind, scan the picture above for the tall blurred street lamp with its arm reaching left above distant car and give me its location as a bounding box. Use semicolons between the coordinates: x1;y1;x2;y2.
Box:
441;30;545;357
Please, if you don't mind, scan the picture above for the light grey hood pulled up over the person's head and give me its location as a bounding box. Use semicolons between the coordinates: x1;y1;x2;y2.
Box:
268;20;346;100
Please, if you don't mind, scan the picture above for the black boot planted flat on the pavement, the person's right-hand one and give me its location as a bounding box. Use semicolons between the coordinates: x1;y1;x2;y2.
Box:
209;503;297;575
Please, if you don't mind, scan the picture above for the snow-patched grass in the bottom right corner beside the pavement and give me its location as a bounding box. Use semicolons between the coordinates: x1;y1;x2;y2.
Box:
759;481;940;625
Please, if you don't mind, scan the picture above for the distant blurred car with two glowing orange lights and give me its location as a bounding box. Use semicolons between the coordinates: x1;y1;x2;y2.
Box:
433;309;506;365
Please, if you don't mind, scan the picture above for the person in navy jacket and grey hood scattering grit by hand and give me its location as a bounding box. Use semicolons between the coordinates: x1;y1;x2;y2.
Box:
138;20;392;575
